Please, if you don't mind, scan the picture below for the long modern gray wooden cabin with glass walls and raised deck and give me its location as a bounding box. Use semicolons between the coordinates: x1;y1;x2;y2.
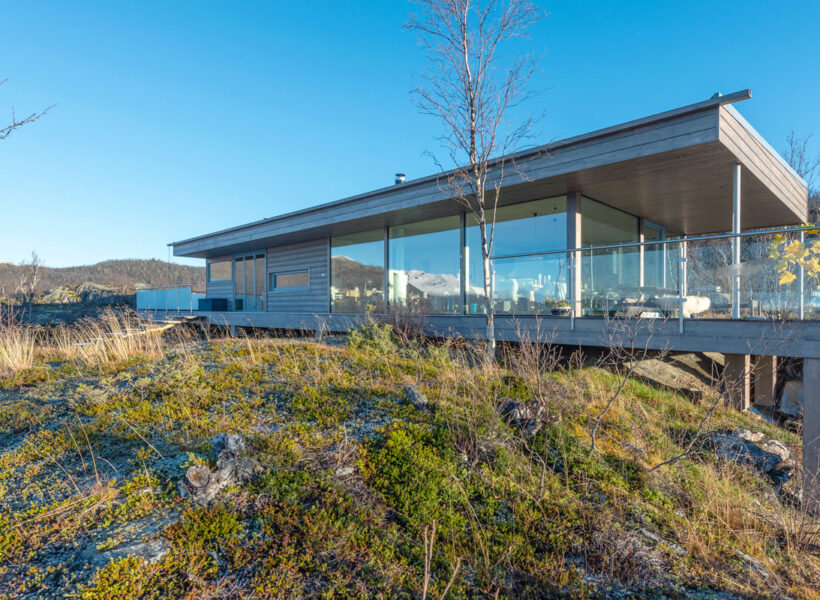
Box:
171;90;820;496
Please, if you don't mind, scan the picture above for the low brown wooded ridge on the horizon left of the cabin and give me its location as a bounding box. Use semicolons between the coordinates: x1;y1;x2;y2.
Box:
0;258;205;296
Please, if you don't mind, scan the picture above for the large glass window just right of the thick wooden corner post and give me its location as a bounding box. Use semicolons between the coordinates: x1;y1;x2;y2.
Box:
581;198;643;315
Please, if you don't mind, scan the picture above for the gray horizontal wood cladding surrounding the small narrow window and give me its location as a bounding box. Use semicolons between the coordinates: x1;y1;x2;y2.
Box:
267;238;330;313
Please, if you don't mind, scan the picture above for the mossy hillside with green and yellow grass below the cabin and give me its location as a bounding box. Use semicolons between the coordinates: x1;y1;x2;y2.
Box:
0;328;820;598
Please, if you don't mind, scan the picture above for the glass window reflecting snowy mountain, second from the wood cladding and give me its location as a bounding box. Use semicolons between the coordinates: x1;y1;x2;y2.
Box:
388;216;461;314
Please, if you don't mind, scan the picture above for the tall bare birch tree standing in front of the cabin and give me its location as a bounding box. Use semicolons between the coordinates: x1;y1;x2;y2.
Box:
407;0;544;359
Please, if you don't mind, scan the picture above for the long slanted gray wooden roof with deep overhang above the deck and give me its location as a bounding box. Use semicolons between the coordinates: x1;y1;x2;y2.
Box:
171;90;808;258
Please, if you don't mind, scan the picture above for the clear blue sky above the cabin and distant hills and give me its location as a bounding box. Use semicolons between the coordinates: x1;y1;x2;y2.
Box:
0;0;820;266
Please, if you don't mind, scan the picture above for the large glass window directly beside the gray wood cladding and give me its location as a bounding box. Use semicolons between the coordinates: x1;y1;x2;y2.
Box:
330;229;384;313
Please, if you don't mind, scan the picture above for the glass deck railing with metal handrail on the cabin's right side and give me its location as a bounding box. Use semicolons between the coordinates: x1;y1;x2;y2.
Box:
492;227;820;329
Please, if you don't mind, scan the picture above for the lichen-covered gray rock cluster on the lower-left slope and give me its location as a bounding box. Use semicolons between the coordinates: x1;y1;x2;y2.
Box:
179;433;259;505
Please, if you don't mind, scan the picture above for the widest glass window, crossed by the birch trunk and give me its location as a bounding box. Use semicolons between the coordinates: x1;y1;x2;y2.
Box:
466;196;569;314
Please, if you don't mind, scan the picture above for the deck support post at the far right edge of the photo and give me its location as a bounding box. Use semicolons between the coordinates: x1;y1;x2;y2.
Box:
803;358;820;508
